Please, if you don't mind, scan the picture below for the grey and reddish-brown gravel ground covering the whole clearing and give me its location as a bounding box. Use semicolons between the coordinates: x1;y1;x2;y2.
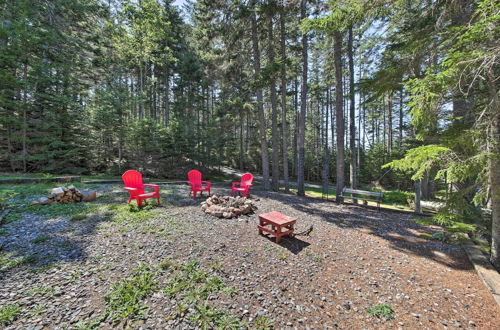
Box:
0;186;500;329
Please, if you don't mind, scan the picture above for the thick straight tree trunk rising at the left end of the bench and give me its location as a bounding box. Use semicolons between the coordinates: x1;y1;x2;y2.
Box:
334;31;344;203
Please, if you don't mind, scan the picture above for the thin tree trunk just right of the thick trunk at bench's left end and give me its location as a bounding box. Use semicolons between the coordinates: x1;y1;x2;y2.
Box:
347;25;357;193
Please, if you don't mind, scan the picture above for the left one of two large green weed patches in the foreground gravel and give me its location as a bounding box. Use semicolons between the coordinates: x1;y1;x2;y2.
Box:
104;265;156;321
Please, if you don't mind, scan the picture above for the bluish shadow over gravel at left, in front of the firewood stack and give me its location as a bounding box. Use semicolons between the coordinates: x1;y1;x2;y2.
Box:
0;189;167;280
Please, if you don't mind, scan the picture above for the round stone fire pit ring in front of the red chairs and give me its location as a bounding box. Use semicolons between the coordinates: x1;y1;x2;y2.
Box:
201;195;257;219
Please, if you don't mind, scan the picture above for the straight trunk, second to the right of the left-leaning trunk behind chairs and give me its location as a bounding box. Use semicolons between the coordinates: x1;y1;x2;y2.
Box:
280;8;290;192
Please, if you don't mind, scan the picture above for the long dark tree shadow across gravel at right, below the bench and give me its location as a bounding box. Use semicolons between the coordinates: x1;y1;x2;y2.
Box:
255;191;472;270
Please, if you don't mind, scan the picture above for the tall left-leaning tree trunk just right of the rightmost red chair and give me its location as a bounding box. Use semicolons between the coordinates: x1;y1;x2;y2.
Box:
251;0;269;190
